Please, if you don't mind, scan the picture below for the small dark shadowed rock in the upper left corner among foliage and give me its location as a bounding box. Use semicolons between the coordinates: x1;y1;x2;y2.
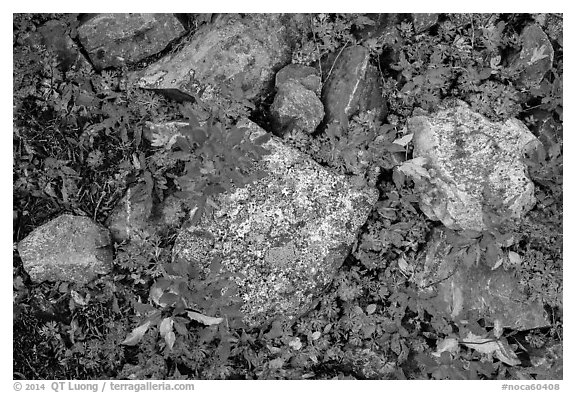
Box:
37;20;88;72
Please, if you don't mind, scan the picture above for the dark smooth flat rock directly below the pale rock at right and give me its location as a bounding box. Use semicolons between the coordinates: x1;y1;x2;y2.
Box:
414;229;550;330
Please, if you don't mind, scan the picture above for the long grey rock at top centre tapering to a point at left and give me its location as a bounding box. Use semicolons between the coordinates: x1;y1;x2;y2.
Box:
133;14;297;101
